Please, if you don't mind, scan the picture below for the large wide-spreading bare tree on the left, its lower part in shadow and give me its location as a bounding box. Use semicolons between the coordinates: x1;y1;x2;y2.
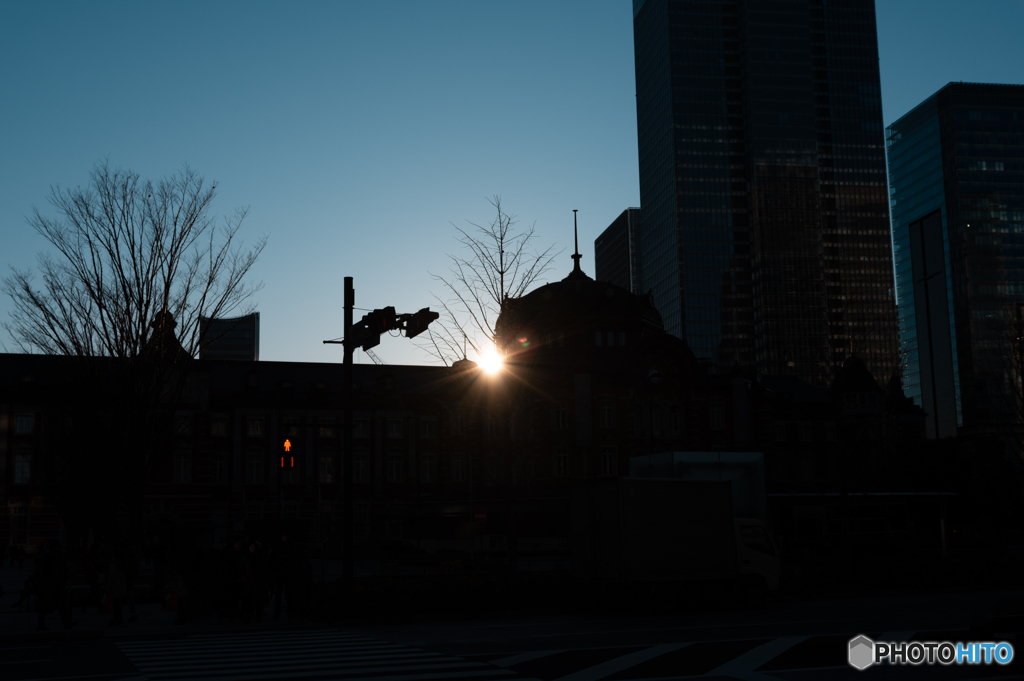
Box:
0;163;266;544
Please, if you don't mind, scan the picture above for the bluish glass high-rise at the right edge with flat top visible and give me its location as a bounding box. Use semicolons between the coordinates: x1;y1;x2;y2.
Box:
886;83;1024;437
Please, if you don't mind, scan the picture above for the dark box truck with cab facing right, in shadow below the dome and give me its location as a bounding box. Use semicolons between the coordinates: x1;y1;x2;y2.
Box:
570;477;779;605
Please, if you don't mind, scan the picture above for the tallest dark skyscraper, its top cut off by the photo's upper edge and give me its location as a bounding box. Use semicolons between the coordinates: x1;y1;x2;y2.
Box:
633;0;898;385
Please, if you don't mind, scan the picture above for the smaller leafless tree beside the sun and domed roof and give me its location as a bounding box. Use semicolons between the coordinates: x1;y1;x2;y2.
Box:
421;196;560;365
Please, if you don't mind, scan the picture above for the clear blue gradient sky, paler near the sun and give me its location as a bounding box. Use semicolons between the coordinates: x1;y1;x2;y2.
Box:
0;0;1024;364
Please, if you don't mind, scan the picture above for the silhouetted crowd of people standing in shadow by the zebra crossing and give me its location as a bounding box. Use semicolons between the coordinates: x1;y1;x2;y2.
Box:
0;535;313;630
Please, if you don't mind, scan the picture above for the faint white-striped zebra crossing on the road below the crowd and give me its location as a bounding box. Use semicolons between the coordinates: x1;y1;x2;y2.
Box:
118;630;521;681
